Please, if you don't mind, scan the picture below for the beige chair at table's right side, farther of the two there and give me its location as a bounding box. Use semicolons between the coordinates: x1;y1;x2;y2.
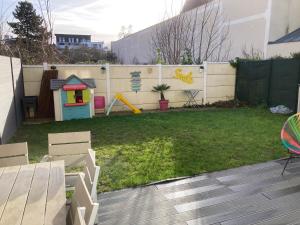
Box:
66;149;100;201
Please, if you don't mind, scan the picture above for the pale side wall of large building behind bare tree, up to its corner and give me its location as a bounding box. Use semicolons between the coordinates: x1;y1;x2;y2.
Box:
112;0;268;64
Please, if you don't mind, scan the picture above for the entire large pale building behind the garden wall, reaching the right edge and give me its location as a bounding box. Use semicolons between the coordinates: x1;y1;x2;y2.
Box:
111;0;300;64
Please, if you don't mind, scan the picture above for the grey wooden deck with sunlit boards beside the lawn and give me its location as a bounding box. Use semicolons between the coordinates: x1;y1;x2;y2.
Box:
98;160;300;225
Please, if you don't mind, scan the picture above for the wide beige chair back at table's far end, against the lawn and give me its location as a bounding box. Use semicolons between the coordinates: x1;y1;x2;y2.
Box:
47;131;91;167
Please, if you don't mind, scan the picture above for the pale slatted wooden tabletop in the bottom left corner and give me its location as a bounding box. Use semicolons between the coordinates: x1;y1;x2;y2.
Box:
0;161;66;225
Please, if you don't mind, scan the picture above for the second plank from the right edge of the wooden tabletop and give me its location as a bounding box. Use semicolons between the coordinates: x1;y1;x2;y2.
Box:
22;163;50;225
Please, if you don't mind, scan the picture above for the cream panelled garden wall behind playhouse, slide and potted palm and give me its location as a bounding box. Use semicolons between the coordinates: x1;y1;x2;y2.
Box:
23;63;235;111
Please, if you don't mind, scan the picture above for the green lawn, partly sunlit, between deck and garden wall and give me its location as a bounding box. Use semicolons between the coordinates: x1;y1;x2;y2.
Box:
12;108;287;191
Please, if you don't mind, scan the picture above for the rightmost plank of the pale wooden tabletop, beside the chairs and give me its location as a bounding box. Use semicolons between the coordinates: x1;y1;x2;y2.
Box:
45;161;66;225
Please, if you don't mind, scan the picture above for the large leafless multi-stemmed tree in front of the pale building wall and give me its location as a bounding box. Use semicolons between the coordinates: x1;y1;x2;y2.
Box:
152;0;231;64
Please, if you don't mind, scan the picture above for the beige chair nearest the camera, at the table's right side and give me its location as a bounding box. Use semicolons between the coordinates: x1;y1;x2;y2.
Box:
68;174;99;225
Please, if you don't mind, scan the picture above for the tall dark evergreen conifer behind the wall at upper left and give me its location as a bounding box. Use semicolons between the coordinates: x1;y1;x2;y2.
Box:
8;1;50;63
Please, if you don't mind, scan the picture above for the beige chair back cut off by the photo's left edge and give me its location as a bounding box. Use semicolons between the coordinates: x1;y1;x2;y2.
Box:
0;142;28;167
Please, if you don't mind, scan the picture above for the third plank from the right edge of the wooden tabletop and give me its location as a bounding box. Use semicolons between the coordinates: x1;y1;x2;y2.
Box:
0;165;35;225
